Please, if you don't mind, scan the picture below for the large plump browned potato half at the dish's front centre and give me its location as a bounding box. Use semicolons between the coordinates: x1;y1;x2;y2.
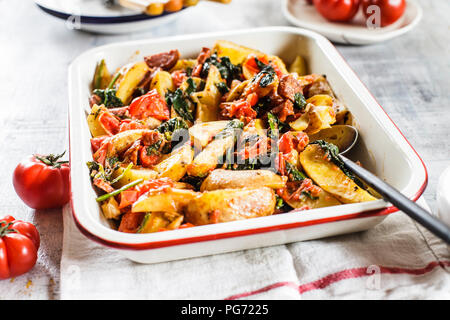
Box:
185;187;276;225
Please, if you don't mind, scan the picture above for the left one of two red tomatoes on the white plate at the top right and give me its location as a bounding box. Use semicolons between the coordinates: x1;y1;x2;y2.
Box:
313;0;359;22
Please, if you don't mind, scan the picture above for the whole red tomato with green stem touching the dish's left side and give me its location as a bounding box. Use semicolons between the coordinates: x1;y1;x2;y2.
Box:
13;152;70;209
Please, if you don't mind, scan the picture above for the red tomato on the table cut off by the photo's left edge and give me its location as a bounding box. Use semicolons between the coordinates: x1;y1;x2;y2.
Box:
0;216;40;279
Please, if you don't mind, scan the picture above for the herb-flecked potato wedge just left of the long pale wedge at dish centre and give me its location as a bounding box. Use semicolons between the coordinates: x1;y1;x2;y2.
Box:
153;143;194;181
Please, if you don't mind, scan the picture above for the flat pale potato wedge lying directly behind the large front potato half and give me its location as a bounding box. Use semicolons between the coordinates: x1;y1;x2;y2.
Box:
200;169;287;192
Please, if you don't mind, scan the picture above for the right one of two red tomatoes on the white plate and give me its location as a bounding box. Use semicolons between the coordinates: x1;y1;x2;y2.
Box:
361;0;406;27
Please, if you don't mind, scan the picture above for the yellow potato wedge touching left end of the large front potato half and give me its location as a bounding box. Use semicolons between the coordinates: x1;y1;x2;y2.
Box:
131;188;197;212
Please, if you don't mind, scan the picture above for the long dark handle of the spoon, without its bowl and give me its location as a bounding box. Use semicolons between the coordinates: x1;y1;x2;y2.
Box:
340;155;450;244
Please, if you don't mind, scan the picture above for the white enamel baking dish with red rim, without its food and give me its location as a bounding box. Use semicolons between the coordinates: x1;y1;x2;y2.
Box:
69;27;427;263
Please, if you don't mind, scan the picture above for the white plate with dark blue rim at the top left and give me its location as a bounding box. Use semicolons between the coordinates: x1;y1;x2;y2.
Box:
35;0;191;34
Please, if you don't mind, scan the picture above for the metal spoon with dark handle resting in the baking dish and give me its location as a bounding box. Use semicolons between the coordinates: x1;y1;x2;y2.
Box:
310;125;450;244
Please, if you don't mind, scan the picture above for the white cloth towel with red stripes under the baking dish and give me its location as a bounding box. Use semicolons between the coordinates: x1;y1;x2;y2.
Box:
60;199;450;299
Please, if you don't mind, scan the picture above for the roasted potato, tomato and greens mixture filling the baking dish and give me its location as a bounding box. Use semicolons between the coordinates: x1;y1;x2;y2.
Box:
87;41;376;233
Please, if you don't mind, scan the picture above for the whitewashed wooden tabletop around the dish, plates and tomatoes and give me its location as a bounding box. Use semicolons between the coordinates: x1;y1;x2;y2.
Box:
0;0;450;300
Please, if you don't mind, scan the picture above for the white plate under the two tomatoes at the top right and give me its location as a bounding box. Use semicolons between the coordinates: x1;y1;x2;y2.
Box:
282;0;422;45
